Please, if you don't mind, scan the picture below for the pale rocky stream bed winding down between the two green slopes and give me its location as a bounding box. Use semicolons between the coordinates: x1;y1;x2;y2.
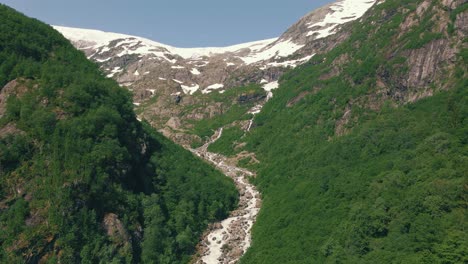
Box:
191;128;262;264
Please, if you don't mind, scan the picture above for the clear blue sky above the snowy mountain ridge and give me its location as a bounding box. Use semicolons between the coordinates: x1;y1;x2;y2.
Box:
0;0;333;47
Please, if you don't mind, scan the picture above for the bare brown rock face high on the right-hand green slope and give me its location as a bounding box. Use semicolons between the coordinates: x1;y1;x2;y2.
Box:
380;0;468;103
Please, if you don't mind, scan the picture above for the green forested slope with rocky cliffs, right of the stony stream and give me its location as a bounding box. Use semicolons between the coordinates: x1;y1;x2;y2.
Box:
242;0;468;263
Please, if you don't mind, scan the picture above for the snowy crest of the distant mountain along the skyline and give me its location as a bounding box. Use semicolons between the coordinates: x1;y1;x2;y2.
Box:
54;0;378;88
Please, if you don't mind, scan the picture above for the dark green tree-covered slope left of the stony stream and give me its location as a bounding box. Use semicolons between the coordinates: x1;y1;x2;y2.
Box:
0;5;237;263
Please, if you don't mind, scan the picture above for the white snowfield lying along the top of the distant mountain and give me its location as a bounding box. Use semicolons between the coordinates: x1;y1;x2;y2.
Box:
54;0;377;71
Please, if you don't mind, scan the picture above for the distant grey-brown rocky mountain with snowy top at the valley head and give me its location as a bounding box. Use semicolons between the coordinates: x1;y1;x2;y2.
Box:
55;0;376;146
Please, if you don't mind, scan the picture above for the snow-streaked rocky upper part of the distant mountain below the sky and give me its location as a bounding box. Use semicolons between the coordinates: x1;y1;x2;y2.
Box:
55;0;376;94
